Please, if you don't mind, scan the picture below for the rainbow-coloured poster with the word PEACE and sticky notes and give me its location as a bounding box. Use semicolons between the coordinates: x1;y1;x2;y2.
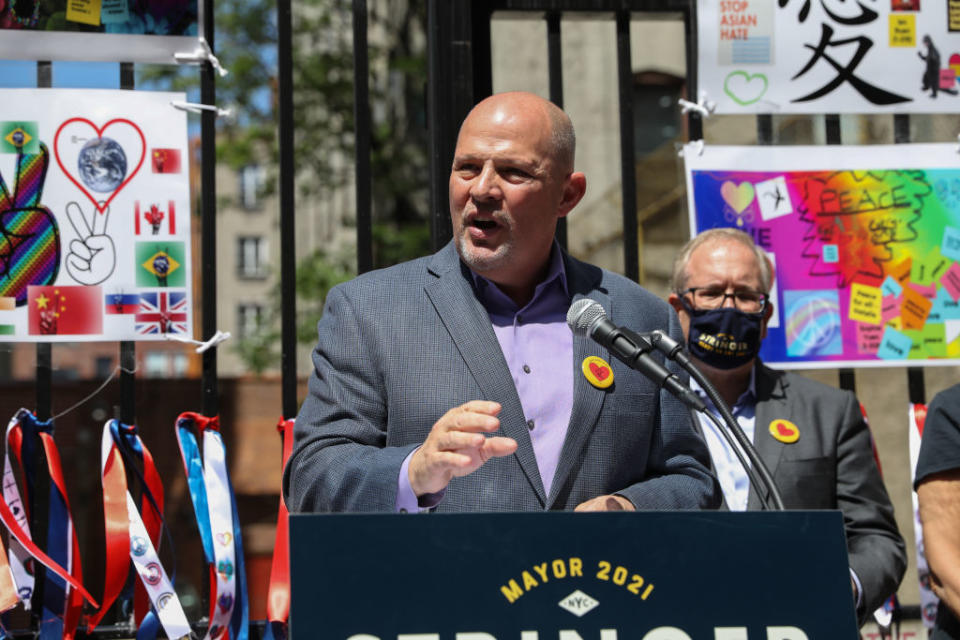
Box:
684;144;960;368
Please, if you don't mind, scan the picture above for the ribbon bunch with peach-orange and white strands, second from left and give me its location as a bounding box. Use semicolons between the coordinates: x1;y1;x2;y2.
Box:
89;420;190;640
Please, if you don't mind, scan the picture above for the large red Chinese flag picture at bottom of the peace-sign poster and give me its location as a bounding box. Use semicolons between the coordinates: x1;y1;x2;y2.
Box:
27;286;103;336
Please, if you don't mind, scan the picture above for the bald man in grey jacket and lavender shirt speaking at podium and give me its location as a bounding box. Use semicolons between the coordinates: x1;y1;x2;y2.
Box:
284;92;719;512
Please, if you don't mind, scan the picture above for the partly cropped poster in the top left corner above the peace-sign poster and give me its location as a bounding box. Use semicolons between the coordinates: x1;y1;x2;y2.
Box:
0;0;201;64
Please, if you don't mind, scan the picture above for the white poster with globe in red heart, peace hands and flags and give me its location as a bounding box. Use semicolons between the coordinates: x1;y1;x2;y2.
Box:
0;89;193;342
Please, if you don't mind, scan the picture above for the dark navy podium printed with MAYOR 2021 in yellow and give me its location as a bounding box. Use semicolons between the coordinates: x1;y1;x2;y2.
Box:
290;511;859;640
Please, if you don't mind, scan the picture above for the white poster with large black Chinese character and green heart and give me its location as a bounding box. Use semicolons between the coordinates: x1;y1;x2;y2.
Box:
697;0;960;113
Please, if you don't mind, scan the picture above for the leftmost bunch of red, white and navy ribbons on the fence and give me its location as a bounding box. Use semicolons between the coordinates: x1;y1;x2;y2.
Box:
0;409;97;640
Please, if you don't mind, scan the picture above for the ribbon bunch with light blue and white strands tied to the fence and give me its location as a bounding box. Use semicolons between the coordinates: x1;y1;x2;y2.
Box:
176;412;249;640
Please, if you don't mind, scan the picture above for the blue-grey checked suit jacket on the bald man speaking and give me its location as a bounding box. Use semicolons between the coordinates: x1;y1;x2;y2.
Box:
284;243;719;512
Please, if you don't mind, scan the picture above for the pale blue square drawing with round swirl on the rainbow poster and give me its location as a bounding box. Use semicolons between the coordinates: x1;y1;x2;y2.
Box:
786;291;840;356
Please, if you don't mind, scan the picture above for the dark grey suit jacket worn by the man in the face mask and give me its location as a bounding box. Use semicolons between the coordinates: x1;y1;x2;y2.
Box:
698;361;907;621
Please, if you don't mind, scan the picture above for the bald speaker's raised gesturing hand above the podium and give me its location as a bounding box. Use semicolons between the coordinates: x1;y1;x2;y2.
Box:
409;400;517;496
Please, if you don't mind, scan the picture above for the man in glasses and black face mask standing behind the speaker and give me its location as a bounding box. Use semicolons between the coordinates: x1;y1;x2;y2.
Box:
669;228;906;623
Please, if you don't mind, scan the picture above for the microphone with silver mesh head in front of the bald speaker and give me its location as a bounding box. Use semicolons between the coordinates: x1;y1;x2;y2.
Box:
567;298;706;411
